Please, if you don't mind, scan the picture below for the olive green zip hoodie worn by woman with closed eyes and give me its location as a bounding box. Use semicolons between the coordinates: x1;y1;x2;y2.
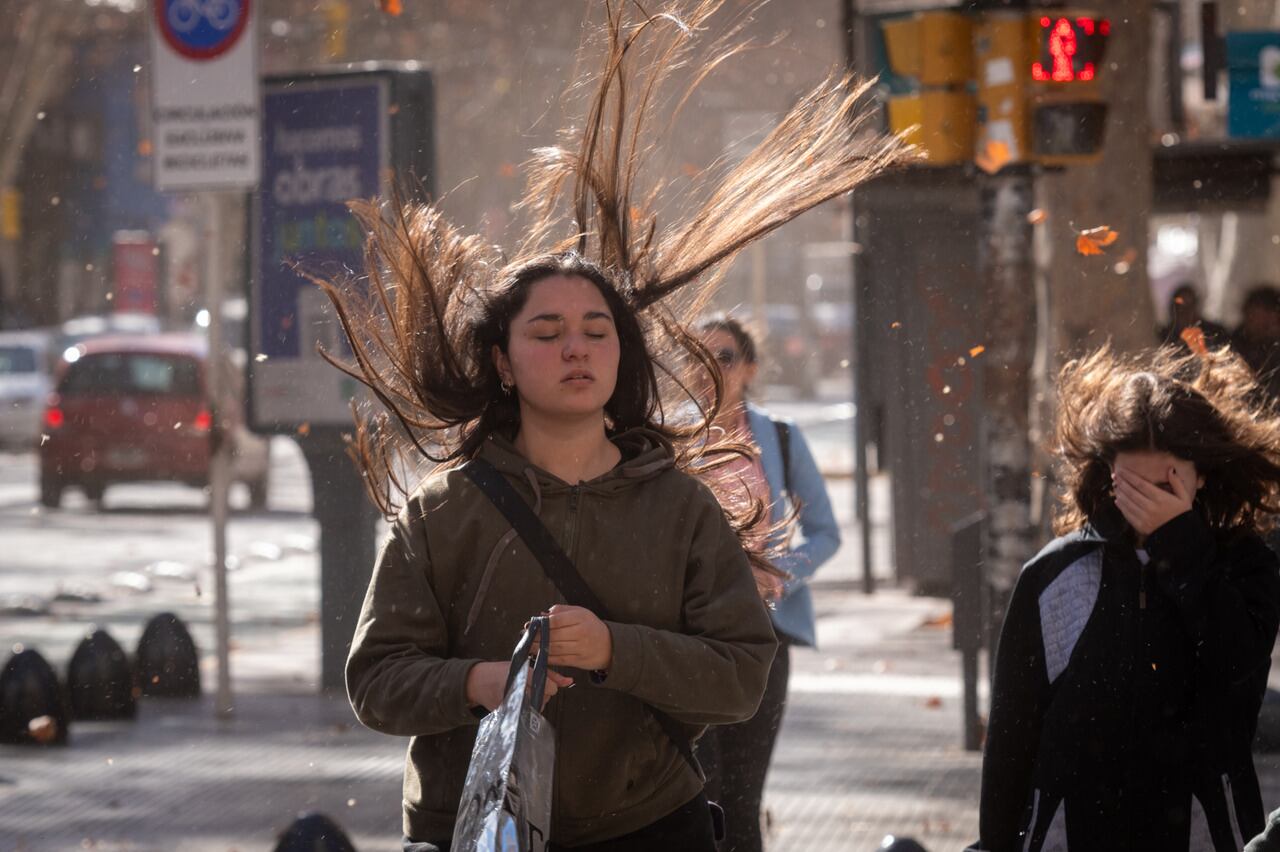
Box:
347;430;776;846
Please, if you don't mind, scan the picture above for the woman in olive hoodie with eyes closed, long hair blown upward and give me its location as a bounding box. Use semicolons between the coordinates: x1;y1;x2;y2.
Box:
312;3;911;852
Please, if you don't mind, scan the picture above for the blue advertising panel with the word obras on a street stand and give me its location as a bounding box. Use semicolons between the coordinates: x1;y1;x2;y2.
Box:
251;78;390;427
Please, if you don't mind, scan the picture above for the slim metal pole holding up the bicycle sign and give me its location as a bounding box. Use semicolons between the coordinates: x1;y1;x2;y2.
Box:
202;192;233;718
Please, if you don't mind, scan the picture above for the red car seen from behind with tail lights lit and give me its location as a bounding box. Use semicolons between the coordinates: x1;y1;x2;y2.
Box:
40;334;270;508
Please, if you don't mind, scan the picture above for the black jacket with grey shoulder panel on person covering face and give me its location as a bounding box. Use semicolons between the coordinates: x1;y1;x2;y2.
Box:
972;510;1280;852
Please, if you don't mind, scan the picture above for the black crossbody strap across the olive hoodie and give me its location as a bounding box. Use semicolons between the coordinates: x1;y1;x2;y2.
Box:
462;458;701;777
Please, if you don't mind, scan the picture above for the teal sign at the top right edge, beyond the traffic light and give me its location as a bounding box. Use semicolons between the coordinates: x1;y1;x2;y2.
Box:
1226;32;1280;139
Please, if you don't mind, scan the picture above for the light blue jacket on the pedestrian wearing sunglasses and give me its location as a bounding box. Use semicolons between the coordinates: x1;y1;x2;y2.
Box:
746;404;840;646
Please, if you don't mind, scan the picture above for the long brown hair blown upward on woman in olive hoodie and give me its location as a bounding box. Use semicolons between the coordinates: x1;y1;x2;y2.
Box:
312;0;916;570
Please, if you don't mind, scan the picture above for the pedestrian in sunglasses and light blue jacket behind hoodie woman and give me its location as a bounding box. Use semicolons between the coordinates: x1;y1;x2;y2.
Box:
698;316;840;852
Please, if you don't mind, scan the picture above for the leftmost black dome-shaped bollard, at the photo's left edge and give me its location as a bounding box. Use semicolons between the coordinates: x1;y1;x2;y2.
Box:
0;650;70;746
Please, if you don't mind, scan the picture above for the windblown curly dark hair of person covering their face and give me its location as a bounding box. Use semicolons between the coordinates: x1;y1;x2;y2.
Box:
1053;345;1280;535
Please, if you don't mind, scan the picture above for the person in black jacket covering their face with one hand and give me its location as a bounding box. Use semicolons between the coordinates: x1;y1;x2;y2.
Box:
974;348;1280;852
